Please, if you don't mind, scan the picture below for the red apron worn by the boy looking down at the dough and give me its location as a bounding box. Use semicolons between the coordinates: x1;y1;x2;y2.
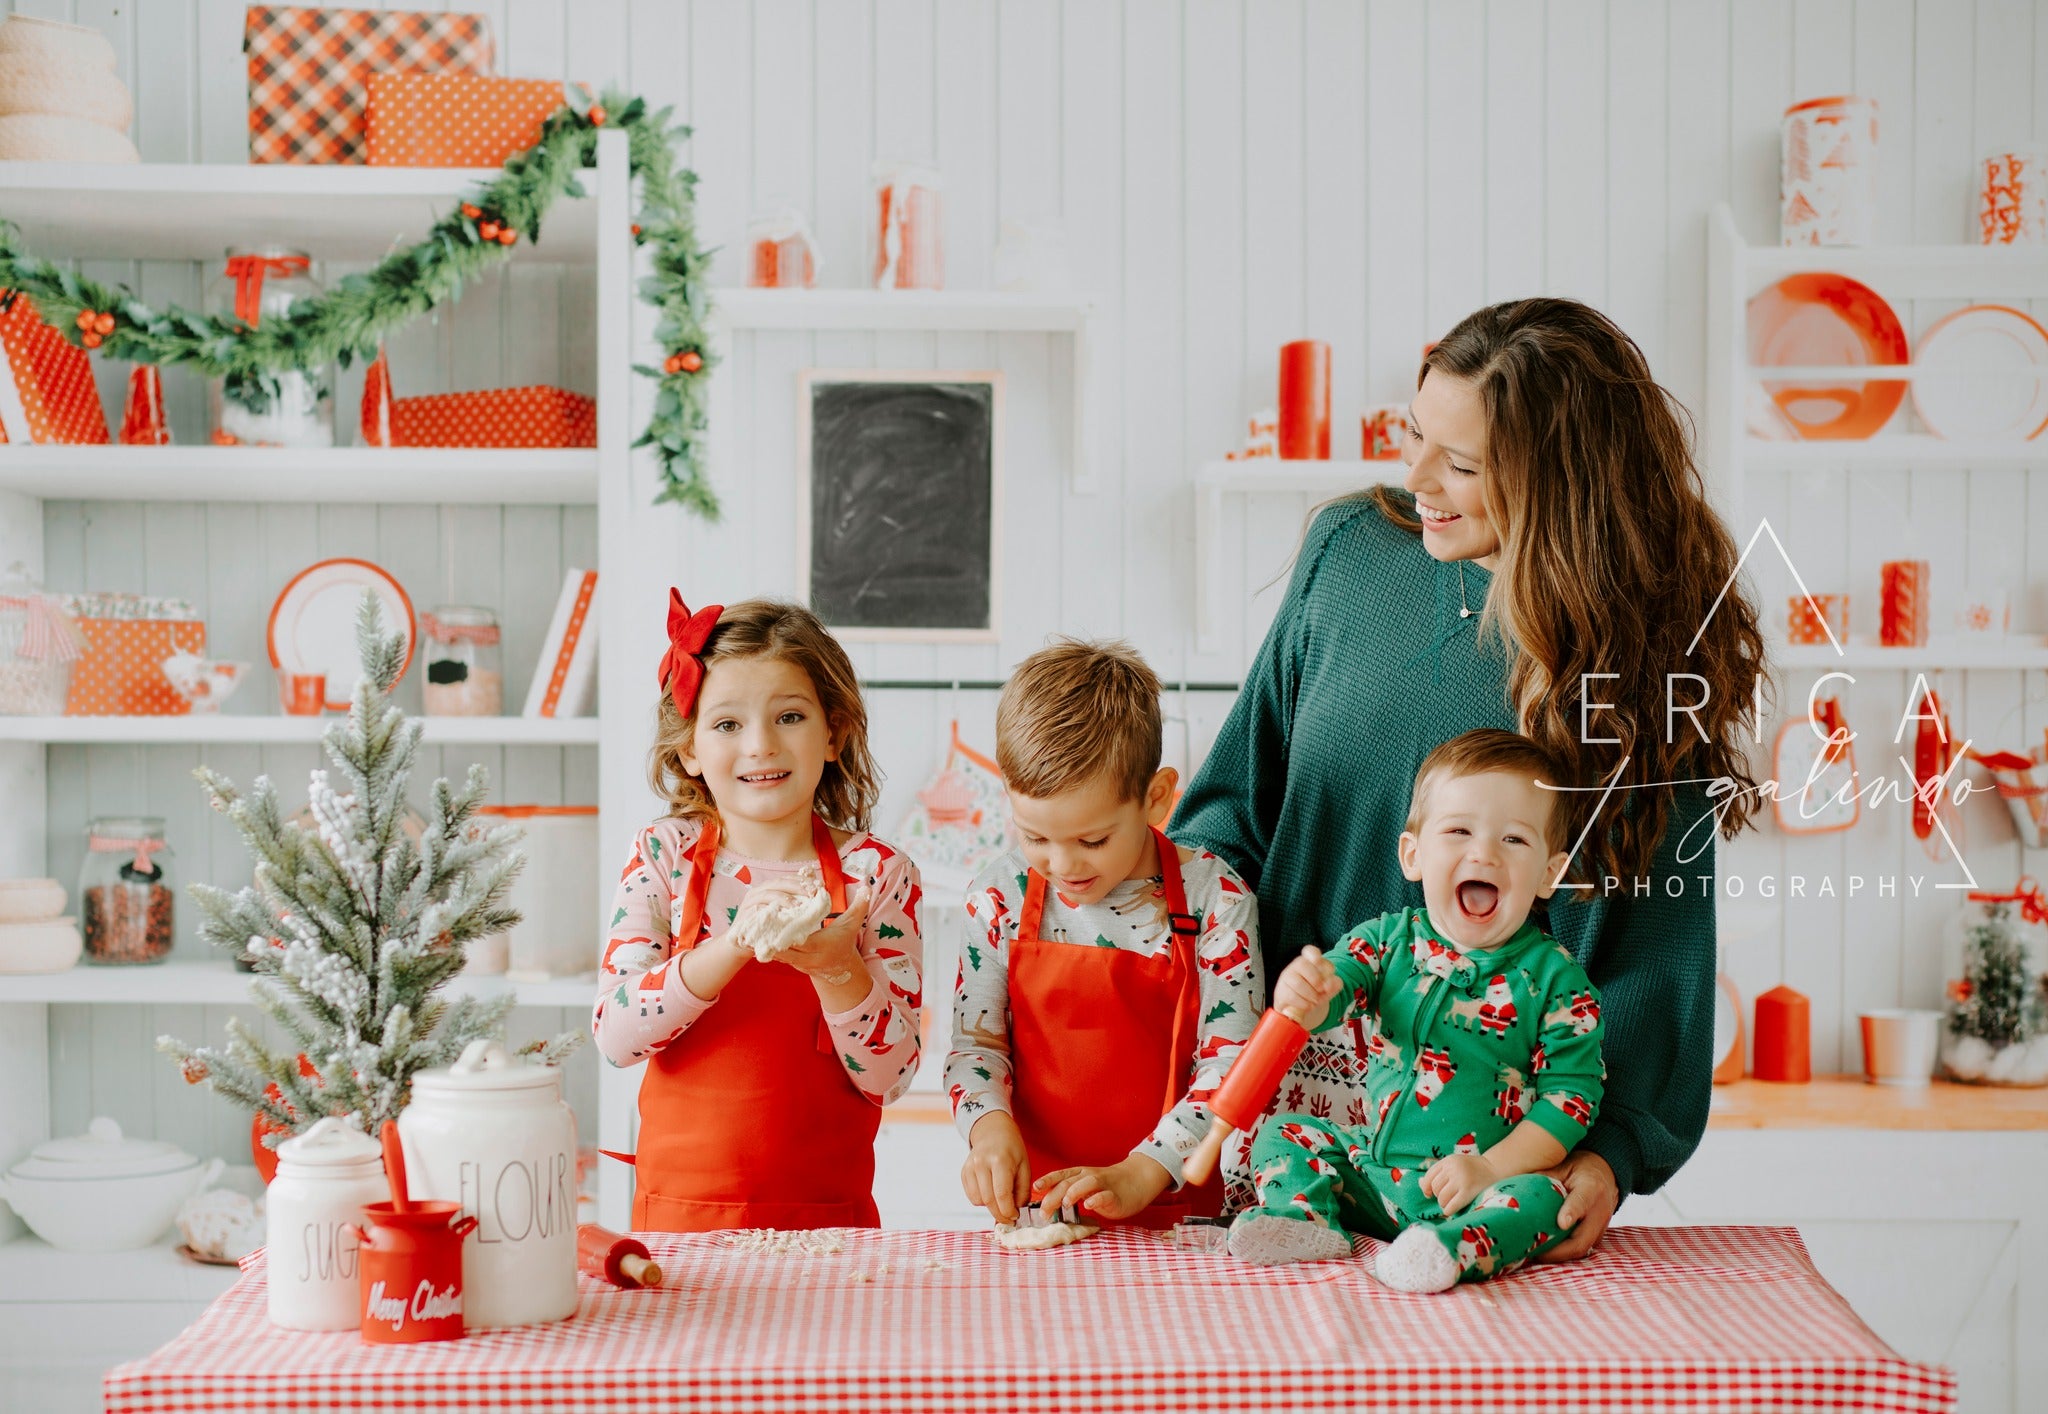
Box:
1010;830;1223;1228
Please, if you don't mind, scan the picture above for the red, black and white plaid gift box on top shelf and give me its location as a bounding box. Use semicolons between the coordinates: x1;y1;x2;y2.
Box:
242;4;492;162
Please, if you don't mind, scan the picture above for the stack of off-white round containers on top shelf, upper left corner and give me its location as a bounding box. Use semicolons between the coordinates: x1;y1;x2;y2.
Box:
0;14;141;162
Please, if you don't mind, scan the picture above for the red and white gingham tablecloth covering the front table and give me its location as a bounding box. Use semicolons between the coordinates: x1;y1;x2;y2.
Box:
106;1228;1956;1414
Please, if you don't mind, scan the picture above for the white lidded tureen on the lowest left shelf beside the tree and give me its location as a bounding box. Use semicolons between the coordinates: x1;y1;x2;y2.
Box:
0;1115;225;1252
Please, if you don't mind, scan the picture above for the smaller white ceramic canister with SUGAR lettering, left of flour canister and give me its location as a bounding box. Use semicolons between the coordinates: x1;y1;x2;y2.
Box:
264;1115;391;1330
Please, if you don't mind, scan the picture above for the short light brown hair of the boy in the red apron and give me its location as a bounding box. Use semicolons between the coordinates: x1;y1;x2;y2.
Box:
995;637;1163;801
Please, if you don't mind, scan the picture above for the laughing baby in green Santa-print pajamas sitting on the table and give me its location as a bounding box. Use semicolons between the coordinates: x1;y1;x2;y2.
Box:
1231;730;1606;1291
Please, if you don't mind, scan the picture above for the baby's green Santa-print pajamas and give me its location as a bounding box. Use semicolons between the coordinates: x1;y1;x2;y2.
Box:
1251;908;1606;1281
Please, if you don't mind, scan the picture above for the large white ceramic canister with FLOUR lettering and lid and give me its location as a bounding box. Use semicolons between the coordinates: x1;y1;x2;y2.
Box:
397;1041;575;1328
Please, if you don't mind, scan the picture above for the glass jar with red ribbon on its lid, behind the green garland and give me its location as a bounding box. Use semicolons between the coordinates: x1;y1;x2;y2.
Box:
207;246;334;447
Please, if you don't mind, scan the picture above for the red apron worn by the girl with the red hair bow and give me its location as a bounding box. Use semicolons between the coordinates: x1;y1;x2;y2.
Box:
633;816;881;1232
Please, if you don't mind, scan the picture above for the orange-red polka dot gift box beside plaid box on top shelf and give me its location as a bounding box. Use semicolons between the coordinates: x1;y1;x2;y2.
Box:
369;74;565;166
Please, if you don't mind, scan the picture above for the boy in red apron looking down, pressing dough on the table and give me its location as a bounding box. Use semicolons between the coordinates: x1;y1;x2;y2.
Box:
946;639;1266;1228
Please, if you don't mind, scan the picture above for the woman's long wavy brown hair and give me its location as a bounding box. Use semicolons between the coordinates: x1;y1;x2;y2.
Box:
1368;299;1765;879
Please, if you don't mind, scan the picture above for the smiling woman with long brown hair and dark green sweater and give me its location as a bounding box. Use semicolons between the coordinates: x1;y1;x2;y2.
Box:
1174;299;1763;1260
